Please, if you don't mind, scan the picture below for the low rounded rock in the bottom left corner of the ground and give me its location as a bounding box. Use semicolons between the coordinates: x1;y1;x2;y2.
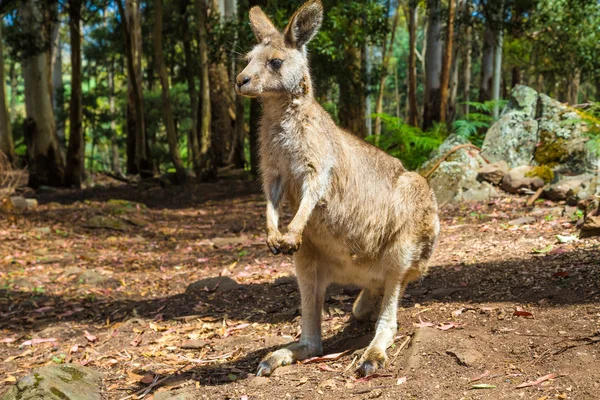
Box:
0;364;102;400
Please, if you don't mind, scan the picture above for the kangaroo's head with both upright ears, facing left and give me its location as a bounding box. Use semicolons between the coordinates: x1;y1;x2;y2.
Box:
235;0;323;97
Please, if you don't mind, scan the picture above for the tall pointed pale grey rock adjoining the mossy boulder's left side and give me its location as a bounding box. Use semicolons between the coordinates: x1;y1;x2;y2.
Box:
481;85;538;168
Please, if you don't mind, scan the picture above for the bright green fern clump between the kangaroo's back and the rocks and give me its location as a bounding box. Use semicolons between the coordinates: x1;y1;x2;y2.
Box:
365;113;448;170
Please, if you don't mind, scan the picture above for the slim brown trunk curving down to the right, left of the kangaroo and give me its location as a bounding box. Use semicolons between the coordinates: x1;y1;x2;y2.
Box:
154;0;187;183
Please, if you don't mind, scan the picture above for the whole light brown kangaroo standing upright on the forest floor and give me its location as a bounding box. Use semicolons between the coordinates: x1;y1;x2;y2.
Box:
235;0;440;376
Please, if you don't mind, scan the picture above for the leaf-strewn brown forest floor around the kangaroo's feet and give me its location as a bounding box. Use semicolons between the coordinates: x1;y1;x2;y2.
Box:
0;176;600;400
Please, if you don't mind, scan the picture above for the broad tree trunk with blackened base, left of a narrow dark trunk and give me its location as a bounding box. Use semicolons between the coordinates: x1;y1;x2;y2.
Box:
20;0;64;188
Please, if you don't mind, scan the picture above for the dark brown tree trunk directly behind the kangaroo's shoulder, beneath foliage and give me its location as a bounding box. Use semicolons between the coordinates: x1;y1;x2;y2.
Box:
338;46;367;138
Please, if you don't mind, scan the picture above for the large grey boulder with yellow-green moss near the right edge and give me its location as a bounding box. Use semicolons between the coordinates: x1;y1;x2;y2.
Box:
534;94;598;174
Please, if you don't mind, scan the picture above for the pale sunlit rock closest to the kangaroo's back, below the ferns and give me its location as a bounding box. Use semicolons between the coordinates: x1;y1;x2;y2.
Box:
421;134;491;205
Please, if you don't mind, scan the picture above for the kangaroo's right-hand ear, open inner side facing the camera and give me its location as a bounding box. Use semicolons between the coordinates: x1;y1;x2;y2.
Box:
283;0;323;49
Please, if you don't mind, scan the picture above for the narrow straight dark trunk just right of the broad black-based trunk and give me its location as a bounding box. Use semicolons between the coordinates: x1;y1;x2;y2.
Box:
65;0;85;188
